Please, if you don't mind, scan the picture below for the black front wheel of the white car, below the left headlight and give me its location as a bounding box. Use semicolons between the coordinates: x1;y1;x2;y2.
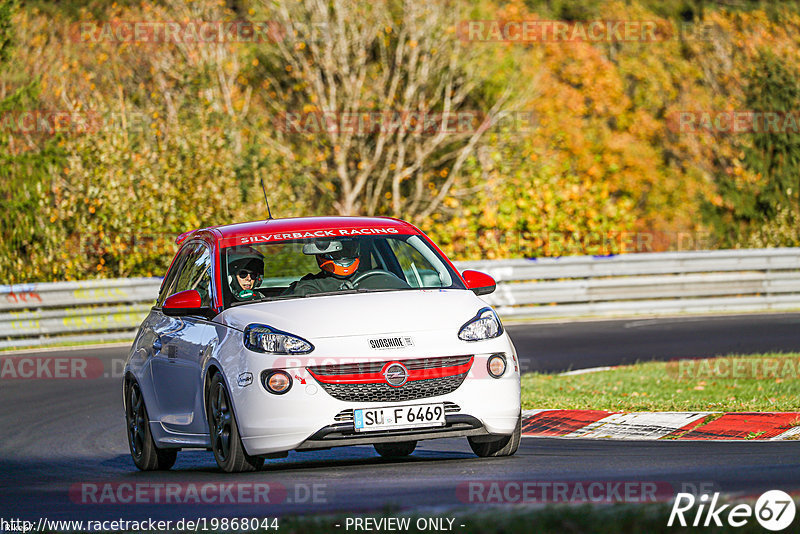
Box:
206;373;264;473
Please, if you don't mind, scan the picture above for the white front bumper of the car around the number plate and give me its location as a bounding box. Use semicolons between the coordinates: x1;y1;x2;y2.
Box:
229;334;520;455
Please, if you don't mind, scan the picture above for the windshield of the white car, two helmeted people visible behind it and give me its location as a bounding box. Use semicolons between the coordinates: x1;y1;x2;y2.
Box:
223;235;465;307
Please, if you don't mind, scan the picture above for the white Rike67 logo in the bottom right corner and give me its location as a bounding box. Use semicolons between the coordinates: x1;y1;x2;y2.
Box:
667;490;796;532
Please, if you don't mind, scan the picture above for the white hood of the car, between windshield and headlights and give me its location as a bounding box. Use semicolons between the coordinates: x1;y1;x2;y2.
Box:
217;289;487;338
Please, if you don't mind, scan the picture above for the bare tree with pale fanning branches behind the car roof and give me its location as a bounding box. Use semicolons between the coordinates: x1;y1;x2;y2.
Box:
253;0;511;221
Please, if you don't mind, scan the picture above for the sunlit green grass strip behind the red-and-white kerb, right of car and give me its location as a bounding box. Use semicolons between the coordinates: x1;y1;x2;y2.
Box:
522;353;800;412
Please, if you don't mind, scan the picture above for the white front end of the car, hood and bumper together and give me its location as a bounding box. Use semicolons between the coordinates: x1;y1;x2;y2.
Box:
214;290;520;454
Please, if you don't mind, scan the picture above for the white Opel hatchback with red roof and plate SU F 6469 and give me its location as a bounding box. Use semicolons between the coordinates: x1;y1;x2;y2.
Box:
123;217;520;472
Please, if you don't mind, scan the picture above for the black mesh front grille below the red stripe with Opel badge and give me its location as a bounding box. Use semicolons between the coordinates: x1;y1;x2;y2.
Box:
320;373;467;402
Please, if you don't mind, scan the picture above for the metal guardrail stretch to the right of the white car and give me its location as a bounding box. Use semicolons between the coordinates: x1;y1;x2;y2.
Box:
459;248;800;318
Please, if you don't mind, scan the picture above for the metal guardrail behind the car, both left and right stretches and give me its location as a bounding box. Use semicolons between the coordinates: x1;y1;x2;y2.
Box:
0;248;800;348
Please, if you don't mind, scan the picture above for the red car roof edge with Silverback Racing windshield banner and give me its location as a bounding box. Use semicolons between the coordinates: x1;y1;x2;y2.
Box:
188;217;420;247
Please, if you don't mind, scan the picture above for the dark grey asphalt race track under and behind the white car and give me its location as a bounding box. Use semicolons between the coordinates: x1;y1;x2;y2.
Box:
0;314;800;531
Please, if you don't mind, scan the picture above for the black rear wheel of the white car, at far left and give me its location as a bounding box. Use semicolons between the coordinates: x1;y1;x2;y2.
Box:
125;379;178;471
